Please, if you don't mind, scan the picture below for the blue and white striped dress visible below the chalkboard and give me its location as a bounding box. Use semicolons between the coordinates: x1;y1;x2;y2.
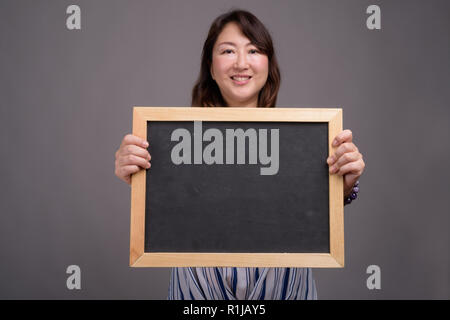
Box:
168;268;317;300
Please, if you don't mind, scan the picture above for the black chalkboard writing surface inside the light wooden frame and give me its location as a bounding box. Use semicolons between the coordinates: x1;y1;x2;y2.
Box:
145;121;330;253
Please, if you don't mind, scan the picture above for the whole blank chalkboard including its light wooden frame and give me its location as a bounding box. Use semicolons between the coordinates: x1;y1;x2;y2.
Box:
130;107;343;267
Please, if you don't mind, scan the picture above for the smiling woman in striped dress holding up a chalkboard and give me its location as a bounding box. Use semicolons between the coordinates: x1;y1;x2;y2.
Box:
115;10;365;300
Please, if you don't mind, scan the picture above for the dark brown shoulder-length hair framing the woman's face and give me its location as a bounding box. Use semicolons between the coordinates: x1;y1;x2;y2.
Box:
192;10;281;108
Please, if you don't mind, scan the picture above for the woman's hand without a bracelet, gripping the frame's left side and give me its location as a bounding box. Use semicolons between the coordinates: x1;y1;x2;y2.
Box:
115;134;151;184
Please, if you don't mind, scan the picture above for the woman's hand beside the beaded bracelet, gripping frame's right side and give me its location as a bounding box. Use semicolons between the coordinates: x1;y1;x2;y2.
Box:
327;130;366;197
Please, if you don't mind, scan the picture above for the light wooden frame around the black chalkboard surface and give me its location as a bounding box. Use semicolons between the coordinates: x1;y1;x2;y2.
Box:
130;107;344;268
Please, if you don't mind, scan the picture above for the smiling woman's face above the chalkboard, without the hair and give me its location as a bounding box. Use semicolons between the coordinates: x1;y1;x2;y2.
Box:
211;22;269;107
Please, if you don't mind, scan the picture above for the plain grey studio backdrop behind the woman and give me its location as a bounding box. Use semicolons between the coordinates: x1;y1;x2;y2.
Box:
0;0;450;299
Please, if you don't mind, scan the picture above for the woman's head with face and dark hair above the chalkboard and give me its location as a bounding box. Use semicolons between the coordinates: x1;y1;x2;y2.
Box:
192;10;280;107
